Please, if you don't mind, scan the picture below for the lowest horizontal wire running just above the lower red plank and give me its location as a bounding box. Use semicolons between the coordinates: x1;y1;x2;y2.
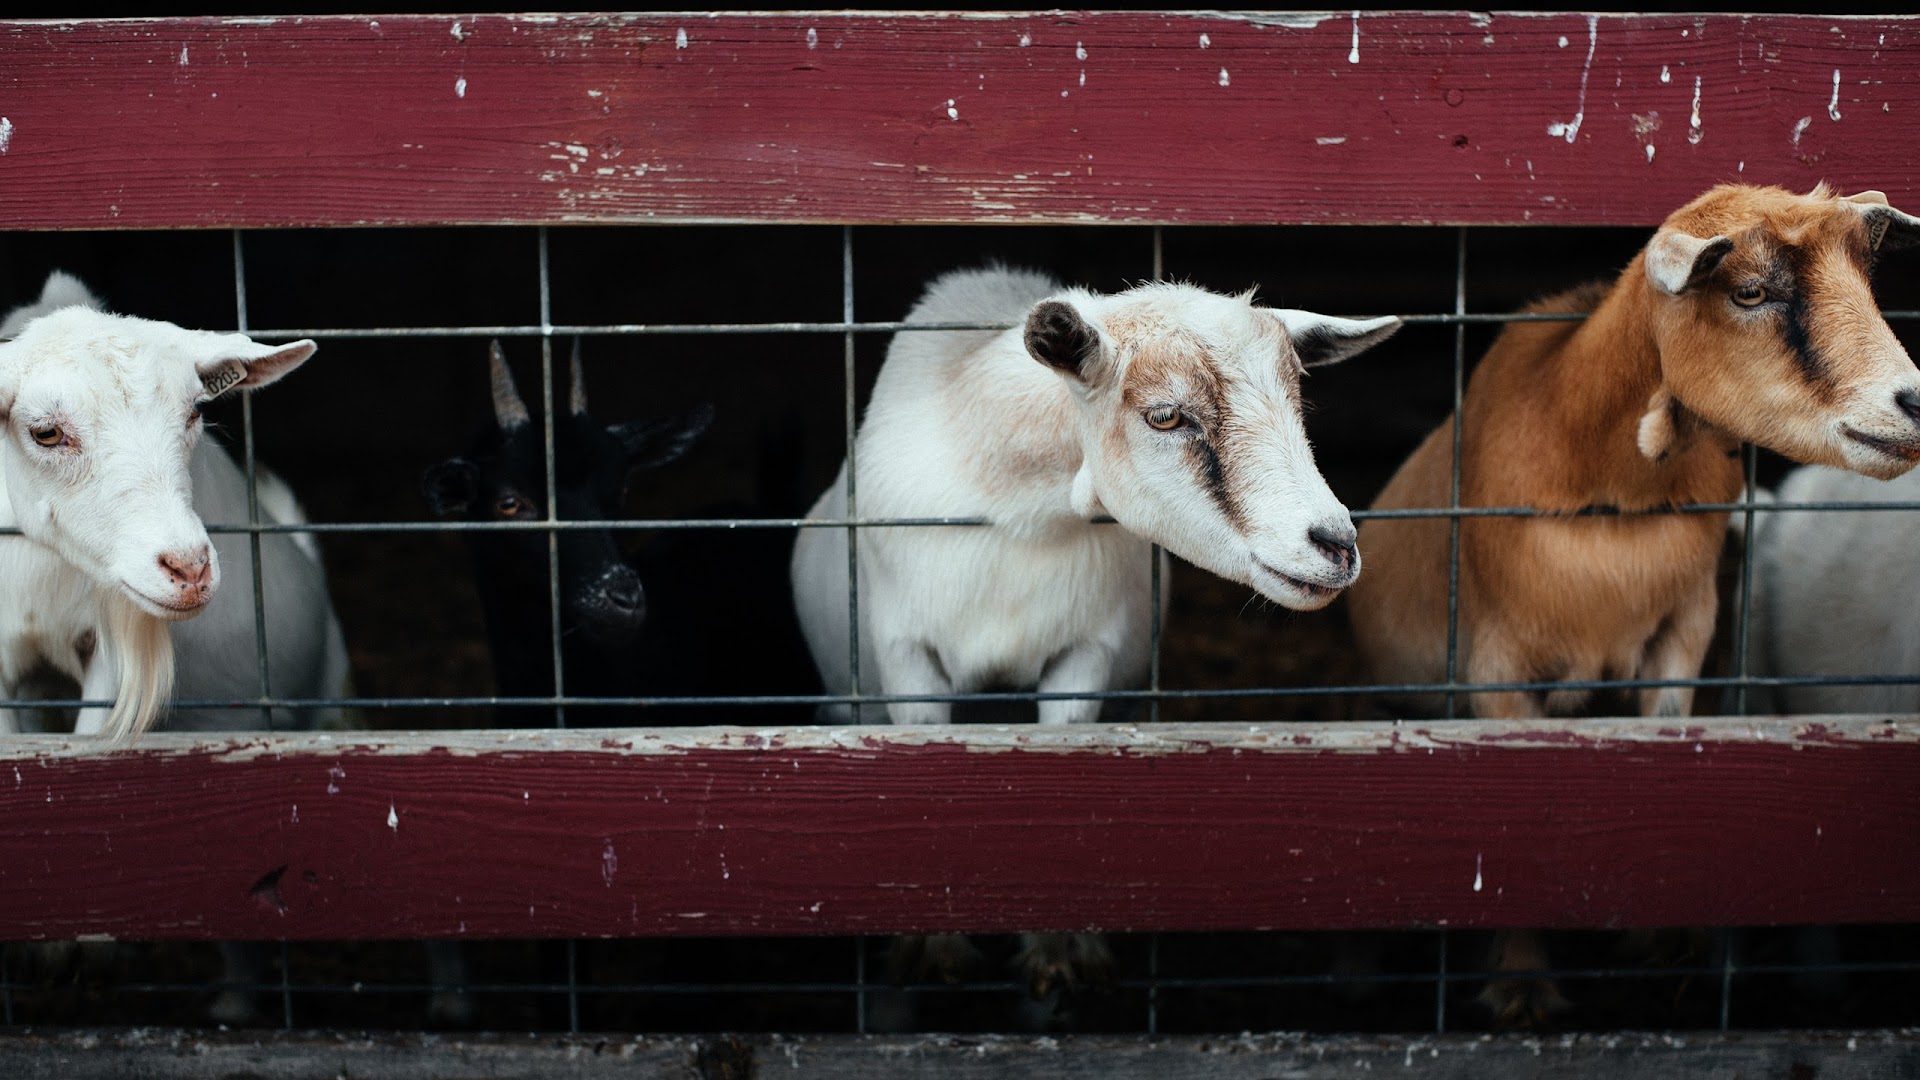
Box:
15;673;1920;714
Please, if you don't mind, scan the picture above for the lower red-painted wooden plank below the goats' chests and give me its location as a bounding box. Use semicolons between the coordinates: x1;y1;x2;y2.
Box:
0;717;1920;940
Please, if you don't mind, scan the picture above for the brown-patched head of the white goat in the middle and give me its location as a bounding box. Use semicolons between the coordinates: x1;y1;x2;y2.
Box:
1025;284;1400;611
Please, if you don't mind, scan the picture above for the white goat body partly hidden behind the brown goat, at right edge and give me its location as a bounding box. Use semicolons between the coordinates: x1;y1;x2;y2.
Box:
1758;465;1920;713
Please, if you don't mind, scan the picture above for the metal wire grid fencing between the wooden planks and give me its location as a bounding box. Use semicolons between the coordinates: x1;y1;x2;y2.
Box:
0;227;1920;1034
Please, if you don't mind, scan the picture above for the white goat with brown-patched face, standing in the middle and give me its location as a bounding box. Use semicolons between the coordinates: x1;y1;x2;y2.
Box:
793;267;1400;997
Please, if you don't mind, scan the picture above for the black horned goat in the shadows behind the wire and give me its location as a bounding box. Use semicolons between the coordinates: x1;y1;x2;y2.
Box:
422;342;818;726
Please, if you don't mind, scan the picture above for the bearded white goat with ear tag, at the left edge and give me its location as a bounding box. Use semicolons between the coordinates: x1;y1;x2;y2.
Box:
0;273;346;736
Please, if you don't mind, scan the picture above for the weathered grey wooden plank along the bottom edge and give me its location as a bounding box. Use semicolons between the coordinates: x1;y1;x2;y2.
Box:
0;1028;1920;1080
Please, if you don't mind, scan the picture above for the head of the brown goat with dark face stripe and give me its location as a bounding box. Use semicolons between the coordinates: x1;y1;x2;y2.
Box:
1640;184;1920;479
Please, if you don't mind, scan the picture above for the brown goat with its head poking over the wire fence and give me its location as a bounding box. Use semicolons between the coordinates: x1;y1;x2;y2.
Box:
1350;184;1920;1022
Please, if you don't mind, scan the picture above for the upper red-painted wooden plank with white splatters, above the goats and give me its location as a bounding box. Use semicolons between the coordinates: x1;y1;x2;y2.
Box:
0;12;1920;229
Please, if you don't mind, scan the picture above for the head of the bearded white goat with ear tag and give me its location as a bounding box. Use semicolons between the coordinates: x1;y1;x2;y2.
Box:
0;273;317;621
